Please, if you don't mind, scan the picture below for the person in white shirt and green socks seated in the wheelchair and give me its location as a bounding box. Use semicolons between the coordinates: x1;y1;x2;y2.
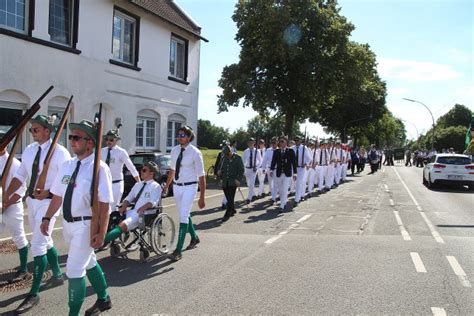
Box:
105;161;162;243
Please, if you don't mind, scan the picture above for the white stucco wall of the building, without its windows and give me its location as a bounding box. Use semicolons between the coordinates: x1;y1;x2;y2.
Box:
0;0;201;153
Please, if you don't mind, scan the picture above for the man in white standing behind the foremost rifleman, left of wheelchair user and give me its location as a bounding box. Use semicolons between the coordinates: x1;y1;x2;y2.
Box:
101;130;140;211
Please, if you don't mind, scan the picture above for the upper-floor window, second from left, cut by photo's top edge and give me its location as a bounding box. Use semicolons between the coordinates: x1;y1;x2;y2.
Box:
48;0;74;46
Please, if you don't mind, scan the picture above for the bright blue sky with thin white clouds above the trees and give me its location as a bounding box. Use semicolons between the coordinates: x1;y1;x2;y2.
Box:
175;0;474;139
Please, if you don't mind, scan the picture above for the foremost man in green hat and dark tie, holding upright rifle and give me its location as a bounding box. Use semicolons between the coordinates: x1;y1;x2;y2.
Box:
41;120;113;315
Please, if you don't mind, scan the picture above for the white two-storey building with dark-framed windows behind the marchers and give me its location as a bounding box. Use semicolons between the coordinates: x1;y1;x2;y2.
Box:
0;0;207;153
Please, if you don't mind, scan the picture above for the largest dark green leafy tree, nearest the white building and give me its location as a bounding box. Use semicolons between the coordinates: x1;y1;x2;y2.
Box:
218;0;354;136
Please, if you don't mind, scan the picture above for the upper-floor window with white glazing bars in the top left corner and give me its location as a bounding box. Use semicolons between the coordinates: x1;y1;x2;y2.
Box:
0;0;29;34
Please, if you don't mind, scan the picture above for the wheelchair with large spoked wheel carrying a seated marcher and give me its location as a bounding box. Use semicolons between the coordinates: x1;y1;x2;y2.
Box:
109;201;176;262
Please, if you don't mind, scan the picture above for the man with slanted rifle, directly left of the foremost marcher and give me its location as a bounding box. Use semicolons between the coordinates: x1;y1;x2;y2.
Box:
3;115;71;314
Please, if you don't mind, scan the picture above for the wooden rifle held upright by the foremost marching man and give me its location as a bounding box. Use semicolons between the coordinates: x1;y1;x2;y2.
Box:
91;103;104;238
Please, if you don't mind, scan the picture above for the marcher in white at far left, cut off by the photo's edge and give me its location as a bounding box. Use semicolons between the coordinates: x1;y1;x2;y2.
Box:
0;135;28;282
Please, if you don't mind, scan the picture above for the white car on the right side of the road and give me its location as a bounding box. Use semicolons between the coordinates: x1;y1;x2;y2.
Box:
423;154;474;191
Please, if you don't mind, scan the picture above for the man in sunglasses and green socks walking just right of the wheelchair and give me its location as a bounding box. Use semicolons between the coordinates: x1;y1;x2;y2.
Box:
164;126;206;261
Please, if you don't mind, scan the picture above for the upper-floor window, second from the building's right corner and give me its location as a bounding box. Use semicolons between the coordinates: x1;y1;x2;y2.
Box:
112;9;138;65
